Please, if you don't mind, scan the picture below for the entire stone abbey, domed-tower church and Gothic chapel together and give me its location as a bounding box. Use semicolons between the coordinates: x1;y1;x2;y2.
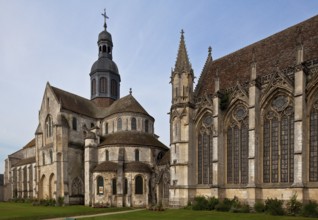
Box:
4;14;318;207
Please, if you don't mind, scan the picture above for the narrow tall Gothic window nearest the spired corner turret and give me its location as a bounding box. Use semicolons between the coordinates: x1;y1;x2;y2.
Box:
197;115;213;184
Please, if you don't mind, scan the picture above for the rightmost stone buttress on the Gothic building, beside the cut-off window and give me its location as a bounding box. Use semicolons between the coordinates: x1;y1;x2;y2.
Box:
293;45;306;190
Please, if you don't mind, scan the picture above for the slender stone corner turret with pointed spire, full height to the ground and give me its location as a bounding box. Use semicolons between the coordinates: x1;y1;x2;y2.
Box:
169;30;195;206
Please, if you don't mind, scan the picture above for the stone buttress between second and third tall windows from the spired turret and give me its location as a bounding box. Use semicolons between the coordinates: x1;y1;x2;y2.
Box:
247;62;260;205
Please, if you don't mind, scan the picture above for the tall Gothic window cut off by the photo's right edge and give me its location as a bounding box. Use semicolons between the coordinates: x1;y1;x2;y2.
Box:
309;100;318;181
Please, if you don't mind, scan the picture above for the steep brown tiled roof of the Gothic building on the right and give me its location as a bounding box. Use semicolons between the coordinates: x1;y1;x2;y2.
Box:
195;16;318;96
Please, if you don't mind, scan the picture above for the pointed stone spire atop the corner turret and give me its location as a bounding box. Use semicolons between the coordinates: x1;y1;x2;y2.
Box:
174;30;192;73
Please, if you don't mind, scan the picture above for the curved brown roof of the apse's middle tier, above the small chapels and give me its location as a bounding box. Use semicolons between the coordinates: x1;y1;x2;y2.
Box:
100;131;169;150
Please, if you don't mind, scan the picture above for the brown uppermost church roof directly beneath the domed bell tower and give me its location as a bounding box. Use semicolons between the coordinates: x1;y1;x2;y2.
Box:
51;86;152;118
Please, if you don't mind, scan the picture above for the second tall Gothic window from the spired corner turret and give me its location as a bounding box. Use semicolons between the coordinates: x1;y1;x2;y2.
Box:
227;105;248;184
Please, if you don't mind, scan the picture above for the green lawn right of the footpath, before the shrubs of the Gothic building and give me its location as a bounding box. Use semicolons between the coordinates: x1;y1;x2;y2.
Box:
84;209;314;220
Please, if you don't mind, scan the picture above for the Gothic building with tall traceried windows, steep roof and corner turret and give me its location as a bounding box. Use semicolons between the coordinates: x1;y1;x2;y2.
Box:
169;16;318;206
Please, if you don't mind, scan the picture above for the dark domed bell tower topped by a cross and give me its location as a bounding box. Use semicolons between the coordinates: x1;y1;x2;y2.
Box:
89;10;120;107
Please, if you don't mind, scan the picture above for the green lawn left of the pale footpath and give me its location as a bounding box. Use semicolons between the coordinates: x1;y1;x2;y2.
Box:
0;202;130;220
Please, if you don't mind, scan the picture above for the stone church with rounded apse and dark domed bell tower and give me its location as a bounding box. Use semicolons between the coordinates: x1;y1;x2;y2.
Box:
4;14;170;207
